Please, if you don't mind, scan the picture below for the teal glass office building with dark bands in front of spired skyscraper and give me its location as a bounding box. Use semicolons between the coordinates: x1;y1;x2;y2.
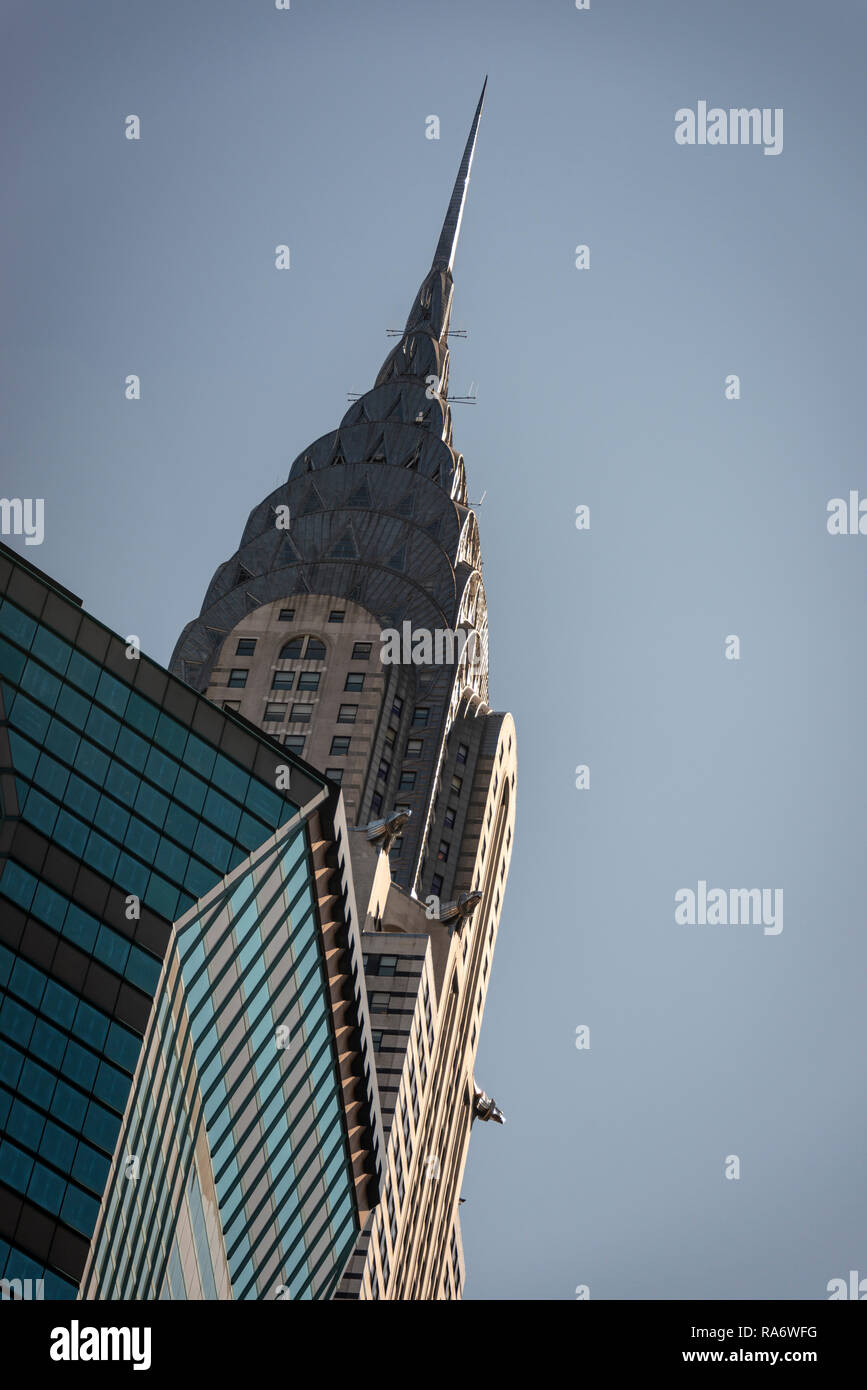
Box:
0;548;375;1298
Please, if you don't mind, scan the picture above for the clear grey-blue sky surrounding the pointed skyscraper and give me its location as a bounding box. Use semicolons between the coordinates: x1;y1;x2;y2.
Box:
0;0;867;1300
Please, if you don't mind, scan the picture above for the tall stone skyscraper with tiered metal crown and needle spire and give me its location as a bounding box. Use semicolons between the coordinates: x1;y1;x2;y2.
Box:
171;81;517;1300
